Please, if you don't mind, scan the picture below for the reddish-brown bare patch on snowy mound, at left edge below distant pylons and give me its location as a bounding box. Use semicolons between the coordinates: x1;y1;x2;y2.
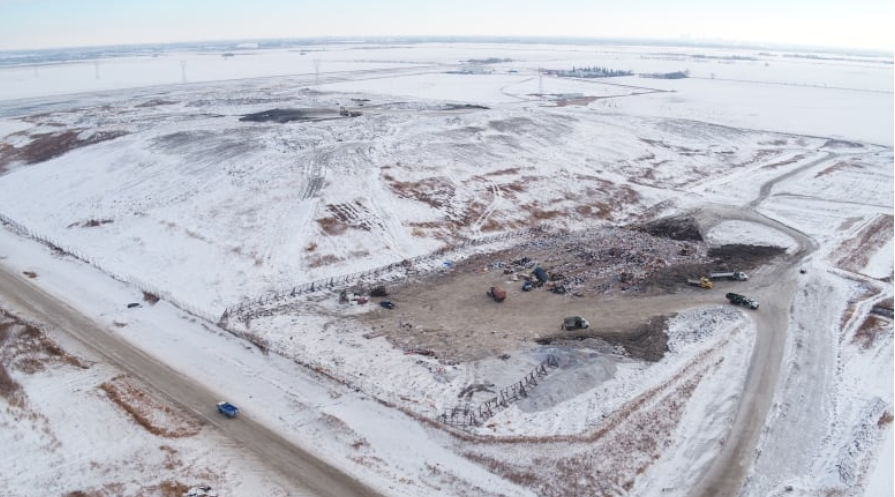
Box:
0;129;127;174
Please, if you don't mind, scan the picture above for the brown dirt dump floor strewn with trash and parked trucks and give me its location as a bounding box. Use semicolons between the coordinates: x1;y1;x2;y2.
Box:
361;223;783;363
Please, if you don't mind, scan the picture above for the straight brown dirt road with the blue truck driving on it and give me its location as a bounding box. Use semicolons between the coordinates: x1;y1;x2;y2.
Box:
0;265;381;497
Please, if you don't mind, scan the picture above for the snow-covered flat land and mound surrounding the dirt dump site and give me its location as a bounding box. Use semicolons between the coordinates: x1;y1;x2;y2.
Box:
0;44;895;497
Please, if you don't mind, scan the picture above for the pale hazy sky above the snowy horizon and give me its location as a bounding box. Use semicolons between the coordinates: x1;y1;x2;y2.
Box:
0;0;895;52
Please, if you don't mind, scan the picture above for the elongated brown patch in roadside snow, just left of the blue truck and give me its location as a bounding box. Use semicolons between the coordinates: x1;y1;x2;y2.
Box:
100;376;202;438
